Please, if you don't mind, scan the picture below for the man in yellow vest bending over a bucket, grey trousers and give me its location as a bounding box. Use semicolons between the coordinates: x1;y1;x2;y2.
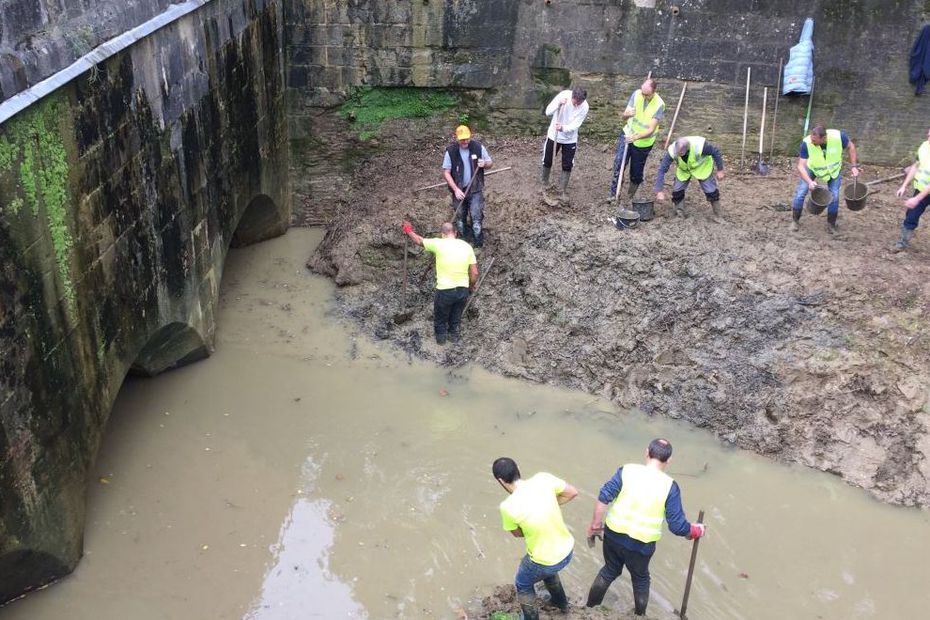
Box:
656;136;724;218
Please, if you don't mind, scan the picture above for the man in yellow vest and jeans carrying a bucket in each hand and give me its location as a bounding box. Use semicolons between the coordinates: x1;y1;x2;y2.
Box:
791;125;859;234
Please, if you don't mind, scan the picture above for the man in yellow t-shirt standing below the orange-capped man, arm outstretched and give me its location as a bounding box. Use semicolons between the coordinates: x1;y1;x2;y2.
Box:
402;222;478;344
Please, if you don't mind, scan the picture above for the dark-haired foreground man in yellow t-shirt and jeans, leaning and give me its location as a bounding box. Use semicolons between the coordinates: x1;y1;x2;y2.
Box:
491;457;578;620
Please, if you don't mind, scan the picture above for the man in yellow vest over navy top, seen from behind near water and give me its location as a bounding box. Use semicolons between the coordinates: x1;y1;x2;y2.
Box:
587;439;704;616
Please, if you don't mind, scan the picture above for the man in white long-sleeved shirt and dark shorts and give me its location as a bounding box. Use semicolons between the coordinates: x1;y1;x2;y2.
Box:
542;87;588;207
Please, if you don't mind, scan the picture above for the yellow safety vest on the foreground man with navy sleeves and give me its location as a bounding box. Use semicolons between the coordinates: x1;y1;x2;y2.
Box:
604;463;674;542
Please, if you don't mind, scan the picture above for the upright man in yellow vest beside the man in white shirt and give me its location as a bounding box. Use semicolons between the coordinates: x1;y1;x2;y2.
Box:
607;77;665;202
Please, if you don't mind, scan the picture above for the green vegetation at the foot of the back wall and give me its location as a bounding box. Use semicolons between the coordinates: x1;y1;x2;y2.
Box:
339;87;459;140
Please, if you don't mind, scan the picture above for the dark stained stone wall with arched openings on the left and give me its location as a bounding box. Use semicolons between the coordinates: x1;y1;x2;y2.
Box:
0;0;290;602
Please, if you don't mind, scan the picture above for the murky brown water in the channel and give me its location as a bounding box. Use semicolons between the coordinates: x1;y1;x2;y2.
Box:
0;230;930;620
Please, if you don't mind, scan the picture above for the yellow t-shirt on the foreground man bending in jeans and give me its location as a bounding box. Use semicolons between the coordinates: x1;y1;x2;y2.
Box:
501;472;575;566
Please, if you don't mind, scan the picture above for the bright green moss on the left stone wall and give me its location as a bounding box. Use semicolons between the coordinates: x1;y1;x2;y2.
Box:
0;95;76;310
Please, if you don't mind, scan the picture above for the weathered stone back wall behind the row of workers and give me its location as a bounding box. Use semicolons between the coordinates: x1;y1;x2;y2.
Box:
287;0;930;218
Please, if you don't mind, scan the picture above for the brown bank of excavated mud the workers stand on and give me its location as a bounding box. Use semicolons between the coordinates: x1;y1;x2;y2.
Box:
309;116;930;506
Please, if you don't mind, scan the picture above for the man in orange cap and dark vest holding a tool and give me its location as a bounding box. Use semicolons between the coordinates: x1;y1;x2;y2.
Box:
442;125;492;248
